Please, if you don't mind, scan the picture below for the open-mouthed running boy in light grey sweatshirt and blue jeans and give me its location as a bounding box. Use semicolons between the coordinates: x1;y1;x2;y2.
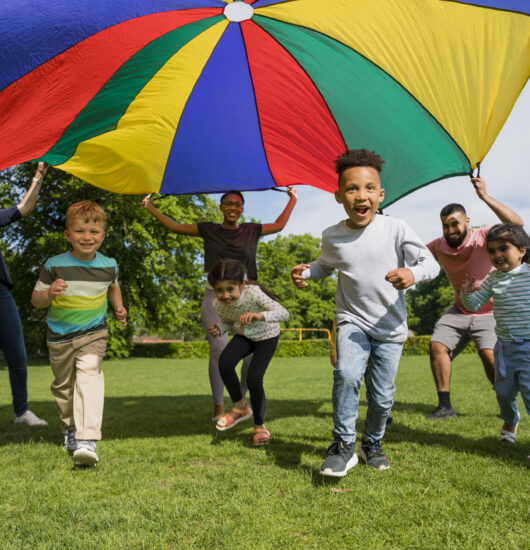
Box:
291;149;440;477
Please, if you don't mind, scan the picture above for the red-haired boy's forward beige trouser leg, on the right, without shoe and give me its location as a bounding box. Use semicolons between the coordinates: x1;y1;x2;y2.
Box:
73;331;108;441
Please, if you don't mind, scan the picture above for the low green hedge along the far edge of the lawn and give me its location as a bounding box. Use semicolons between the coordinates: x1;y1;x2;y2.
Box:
132;336;476;359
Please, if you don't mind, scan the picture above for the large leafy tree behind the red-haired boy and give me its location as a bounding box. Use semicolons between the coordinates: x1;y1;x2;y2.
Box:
0;163;219;356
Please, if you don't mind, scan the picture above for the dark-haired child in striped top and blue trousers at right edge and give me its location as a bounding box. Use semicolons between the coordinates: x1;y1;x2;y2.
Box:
460;223;530;459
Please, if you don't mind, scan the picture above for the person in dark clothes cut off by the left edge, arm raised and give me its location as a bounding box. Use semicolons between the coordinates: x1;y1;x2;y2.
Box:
0;162;48;426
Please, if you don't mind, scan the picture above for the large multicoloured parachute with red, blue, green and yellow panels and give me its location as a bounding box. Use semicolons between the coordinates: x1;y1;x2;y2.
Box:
0;0;530;204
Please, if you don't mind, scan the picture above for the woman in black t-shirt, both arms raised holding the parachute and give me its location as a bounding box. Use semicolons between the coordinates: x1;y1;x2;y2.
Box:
142;187;297;422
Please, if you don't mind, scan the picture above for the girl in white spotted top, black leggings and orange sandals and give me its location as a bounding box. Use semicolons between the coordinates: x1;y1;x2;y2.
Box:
208;259;289;445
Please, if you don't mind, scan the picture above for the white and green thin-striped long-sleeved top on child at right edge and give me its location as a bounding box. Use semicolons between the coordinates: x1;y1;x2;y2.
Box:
460;263;530;342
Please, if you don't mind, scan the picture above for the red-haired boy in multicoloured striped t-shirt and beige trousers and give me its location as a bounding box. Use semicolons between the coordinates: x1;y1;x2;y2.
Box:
31;201;127;465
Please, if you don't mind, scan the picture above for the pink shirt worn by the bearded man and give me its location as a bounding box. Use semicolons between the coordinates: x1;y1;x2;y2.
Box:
427;227;493;315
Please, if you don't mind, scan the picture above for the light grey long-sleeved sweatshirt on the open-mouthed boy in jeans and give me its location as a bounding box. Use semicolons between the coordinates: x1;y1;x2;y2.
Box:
302;215;440;342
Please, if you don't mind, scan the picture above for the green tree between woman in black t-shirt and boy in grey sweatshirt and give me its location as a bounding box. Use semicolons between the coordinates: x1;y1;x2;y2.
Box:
257;234;337;329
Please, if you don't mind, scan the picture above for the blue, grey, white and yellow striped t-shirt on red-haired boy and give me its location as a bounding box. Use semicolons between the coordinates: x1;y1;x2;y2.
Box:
35;252;118;342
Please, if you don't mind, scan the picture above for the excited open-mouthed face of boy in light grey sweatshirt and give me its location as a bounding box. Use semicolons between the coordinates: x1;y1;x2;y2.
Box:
335;166;385;229
